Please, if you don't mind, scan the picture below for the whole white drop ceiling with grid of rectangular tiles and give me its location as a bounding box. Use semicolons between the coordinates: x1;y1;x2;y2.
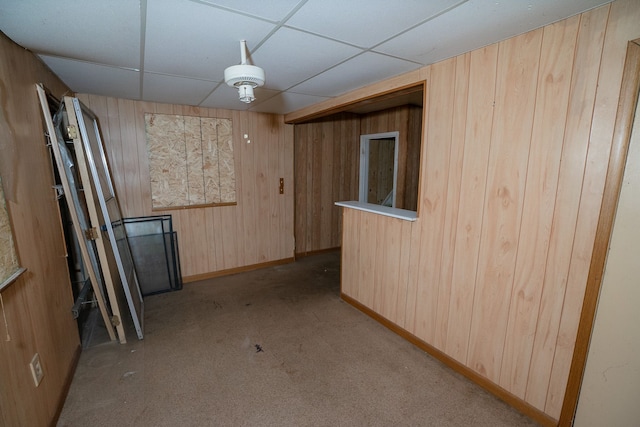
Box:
0;0;609;114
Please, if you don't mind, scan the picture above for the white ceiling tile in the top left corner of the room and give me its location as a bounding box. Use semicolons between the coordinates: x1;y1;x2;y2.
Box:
0;0;140;68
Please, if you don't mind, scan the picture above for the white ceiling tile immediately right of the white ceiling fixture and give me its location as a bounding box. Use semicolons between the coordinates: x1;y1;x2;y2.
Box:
252;28;361;90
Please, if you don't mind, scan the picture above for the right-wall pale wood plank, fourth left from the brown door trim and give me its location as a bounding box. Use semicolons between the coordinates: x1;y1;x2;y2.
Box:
468;30;542;382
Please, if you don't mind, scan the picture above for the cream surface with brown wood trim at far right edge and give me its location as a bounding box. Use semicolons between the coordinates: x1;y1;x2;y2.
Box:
559;39;640;426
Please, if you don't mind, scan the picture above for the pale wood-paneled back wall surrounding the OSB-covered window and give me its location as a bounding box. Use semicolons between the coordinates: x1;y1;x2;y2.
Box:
78;94;294;281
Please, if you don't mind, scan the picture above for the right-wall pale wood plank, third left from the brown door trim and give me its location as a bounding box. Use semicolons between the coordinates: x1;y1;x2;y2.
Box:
500;17;580;398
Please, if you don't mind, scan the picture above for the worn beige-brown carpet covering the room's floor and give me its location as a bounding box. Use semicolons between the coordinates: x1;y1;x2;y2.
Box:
58;252;536;427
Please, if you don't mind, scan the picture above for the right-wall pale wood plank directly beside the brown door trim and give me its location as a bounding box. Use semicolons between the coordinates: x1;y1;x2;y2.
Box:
545;1;640;414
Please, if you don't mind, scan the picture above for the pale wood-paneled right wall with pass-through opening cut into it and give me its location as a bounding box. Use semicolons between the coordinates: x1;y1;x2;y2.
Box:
342;0;640;419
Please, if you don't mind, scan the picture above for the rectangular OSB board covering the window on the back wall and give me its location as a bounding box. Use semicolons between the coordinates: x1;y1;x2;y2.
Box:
145;113;236;209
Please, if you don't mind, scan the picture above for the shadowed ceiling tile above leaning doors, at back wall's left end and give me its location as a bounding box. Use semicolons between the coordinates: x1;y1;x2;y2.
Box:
39;55;140;99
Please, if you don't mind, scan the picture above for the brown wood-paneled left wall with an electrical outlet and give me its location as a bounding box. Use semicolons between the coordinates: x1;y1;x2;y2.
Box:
0;34;80;426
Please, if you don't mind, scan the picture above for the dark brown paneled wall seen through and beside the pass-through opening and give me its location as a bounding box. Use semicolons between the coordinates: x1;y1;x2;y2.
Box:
295;105;422;254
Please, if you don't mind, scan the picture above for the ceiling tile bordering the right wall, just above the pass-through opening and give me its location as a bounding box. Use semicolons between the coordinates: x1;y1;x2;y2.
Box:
291;52;420;96
